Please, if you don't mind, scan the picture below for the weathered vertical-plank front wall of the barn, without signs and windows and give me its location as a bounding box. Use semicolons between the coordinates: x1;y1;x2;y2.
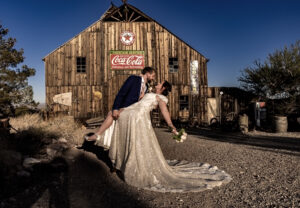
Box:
45;21;207;121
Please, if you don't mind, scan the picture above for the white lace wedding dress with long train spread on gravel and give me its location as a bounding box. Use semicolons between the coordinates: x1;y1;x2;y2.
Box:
99;93;231;192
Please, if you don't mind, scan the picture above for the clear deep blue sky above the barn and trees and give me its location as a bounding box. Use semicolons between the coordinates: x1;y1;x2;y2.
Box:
0;0;300;103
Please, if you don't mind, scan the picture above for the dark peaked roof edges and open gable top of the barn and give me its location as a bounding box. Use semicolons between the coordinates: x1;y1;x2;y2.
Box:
43;1;209;62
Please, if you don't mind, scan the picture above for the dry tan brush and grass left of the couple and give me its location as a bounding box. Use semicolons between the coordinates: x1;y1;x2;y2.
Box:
10;114;85;145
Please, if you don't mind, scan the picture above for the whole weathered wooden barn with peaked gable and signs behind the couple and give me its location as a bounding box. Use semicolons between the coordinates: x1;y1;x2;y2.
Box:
43;1;208;124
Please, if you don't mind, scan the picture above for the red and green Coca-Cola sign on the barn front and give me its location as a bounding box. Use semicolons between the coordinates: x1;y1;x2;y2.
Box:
110;51;145;69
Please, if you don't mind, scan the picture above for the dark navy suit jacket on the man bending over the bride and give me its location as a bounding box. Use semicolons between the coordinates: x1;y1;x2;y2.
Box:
113;75;148;110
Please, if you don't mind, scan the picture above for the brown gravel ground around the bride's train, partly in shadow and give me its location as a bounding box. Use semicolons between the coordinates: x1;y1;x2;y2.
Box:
5;129;300;208
